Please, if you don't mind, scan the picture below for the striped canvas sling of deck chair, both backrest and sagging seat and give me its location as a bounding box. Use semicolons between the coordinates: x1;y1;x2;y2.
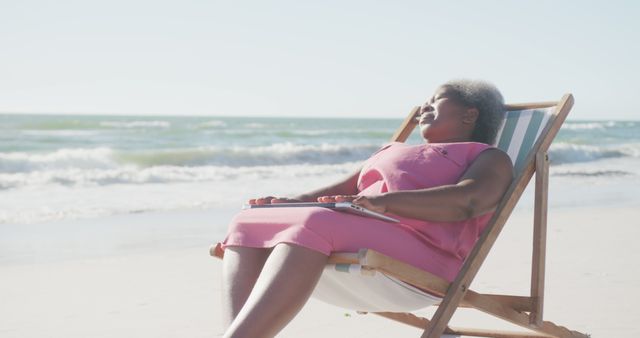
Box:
313;107;555;312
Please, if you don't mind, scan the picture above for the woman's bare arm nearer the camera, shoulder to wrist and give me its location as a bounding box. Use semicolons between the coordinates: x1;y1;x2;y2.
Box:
378;149;513;222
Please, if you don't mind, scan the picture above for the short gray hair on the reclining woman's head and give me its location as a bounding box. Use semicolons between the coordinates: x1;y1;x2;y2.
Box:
442;79;505;144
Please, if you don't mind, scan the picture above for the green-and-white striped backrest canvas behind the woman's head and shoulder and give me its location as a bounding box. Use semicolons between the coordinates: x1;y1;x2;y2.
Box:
495;107;555;173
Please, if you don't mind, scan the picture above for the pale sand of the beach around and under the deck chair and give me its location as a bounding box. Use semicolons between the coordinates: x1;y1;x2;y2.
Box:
0;205;640;338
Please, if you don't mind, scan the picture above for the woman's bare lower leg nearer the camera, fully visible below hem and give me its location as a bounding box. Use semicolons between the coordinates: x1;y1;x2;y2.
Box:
225;243;328;338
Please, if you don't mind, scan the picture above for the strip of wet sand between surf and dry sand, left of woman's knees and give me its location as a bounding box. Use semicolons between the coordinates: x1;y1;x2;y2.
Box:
0;208;234;266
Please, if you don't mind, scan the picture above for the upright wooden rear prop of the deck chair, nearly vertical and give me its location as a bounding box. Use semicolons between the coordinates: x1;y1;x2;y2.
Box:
531;152;549;326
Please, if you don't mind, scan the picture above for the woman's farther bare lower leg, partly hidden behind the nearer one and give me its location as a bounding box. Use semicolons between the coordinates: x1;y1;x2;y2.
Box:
222;246;271;328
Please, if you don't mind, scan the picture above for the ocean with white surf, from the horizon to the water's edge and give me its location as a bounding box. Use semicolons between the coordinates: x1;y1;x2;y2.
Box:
0;114;640;223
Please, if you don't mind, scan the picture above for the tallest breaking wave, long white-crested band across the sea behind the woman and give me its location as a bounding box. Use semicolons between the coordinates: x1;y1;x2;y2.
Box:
0;142;640;180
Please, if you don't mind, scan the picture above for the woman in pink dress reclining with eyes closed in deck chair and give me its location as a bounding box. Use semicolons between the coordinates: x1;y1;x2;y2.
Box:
218;80;513;337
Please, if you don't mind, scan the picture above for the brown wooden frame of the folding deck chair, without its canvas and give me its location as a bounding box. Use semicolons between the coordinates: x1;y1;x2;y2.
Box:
211;94;590;338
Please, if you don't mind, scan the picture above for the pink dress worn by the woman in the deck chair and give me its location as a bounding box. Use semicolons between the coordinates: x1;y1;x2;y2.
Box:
222;142;493;281
